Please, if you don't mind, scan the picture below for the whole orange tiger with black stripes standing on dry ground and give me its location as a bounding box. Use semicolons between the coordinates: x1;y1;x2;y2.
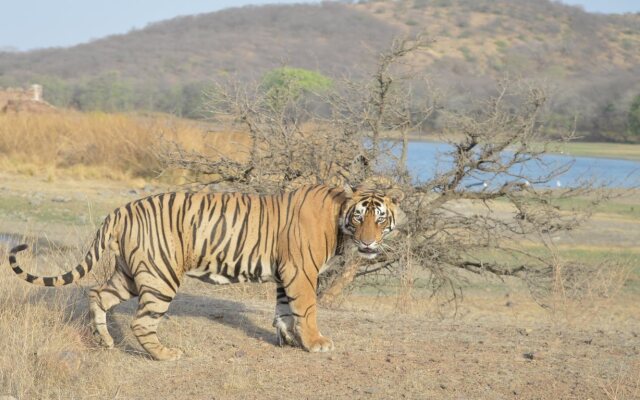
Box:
9;185;404;360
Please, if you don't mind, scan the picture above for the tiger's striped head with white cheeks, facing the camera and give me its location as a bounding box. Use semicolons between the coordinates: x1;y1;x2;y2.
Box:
341;185;404;259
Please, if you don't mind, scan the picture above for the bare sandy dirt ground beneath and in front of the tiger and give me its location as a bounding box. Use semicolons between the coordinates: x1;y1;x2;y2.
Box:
92;281;640;399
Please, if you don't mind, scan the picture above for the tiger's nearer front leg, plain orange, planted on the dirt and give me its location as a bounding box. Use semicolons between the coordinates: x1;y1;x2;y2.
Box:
280;266;333;353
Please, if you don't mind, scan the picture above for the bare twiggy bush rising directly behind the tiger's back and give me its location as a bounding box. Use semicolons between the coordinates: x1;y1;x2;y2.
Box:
163;68;376;193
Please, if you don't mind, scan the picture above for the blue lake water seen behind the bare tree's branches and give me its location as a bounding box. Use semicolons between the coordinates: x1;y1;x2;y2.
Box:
407;142;640;188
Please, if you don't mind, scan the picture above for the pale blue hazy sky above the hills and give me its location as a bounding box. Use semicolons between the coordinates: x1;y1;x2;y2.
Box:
0;0;640;50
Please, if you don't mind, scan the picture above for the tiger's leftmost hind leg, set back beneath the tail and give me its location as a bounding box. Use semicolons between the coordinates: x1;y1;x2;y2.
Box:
89;270;137;349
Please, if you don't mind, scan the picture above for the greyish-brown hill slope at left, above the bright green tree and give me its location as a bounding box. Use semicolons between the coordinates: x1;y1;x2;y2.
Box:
0;4;400;83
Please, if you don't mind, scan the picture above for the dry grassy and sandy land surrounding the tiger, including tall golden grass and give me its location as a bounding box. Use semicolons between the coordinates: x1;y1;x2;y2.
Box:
0;113;640;399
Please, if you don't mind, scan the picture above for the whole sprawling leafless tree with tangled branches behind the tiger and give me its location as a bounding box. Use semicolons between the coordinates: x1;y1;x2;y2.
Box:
160;36;624;310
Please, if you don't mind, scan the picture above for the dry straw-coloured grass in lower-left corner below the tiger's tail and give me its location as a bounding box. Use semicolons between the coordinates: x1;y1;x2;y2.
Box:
0;242;112;399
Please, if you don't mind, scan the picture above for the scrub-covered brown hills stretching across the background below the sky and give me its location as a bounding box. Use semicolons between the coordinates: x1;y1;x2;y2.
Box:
0;0;640;141
